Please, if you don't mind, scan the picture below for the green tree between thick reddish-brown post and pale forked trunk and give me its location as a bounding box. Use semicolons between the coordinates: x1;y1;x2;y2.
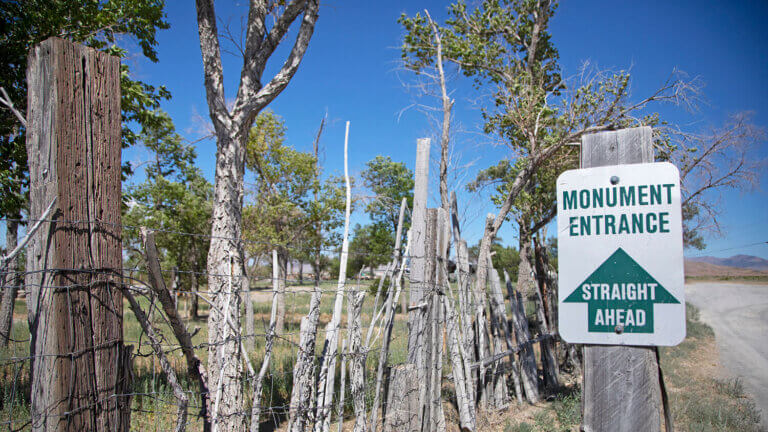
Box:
123;112;213;318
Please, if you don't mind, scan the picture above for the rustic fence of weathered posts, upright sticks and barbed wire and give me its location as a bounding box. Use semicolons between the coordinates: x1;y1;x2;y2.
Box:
0;38;576;432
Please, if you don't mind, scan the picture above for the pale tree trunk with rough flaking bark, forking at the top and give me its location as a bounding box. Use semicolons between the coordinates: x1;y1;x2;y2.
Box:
196;0;319;430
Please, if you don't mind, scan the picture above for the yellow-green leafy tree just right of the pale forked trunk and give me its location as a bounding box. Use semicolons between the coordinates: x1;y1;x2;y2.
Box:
243;110;345;331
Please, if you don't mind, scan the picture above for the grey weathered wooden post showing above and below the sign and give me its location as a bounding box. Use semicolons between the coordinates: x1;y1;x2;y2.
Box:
581;127;661;432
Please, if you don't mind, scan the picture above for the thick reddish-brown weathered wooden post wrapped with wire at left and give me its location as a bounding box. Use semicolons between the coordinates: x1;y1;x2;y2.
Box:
26;38;130;431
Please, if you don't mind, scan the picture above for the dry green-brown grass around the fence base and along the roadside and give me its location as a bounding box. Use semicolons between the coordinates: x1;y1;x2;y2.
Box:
0;284;759;432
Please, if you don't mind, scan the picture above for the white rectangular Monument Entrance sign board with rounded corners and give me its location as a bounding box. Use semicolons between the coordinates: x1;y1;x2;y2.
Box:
557;162;685;346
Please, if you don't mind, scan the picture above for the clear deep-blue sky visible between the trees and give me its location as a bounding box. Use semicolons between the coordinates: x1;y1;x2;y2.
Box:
124;0;768;258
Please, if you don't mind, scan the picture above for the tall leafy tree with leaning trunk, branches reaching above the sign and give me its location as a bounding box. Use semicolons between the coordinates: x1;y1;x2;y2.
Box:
400;0;681;296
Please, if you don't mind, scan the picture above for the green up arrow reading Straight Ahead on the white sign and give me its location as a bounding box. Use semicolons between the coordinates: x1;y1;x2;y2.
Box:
563;248;680;333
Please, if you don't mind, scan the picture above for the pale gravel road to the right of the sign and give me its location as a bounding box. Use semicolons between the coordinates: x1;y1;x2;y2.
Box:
685;282;768;427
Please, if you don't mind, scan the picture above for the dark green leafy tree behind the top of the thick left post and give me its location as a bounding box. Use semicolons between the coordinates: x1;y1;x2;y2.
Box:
0;0;170;221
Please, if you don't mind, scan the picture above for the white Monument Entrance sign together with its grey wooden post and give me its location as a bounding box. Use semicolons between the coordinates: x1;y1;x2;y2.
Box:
557;127;685;432
